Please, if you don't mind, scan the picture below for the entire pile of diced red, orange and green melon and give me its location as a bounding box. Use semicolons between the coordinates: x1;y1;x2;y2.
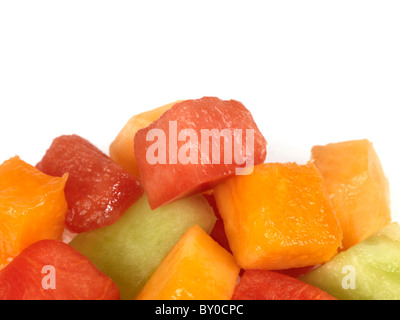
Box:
0;97;400;300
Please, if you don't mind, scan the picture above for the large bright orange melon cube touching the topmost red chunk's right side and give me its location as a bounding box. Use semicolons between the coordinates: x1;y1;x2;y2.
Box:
214;163;342;270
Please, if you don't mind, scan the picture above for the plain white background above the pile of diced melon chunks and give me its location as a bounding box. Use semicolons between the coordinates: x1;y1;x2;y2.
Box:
0;0;400;220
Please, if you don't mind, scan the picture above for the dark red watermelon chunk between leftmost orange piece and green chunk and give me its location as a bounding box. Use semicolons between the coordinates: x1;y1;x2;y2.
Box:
37;135;143;233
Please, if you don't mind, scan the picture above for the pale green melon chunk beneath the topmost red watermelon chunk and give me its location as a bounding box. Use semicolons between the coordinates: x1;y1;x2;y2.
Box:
71;195;215;299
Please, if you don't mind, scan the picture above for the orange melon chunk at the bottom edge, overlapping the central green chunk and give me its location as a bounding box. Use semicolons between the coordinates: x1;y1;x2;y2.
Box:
137;226;240;300
